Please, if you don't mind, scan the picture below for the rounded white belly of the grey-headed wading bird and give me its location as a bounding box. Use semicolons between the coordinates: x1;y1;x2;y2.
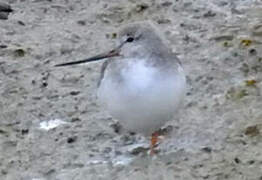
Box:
98;62;186;135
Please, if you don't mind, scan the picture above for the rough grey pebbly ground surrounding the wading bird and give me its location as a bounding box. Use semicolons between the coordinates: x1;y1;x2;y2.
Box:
0;0;262;180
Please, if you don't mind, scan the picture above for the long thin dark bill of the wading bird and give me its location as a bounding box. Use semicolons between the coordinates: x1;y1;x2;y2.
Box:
55;49;119;67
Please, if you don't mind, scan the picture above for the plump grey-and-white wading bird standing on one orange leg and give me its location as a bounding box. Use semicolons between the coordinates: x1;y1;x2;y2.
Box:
55;21;186;154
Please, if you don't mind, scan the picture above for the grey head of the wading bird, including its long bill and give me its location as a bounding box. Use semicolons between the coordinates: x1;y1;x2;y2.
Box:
55;21;165;66
